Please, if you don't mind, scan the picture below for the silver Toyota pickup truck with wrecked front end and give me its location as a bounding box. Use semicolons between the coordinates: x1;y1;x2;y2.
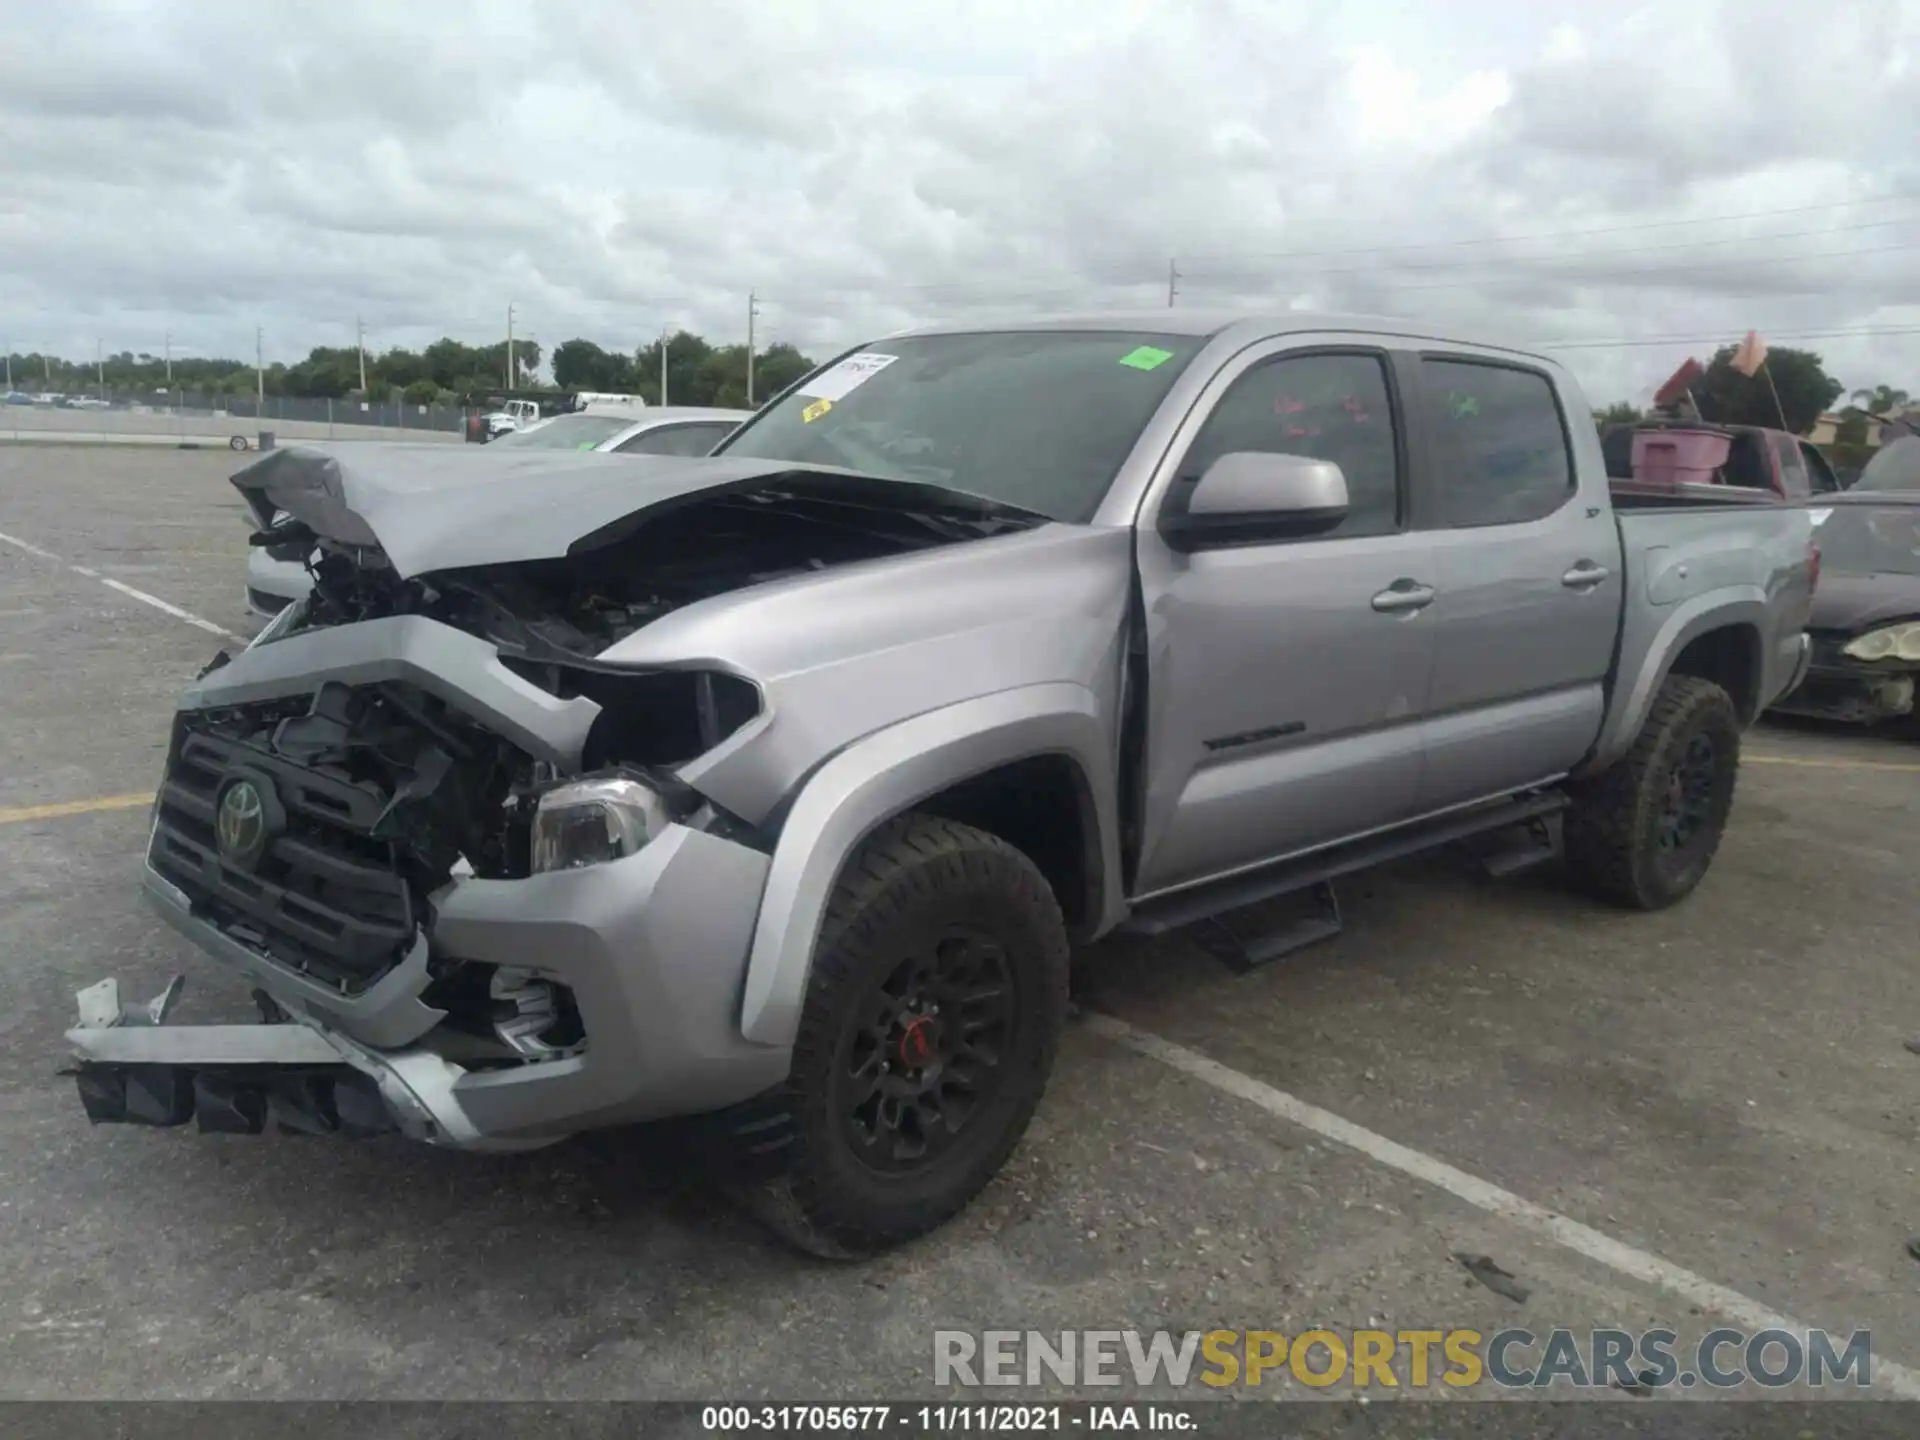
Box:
69;311;1818;1256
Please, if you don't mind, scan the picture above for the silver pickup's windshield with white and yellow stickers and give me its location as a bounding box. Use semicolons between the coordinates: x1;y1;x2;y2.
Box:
722;330;1206;522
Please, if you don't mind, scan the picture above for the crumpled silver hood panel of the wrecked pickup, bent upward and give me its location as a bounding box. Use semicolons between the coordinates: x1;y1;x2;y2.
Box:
232;440;960;580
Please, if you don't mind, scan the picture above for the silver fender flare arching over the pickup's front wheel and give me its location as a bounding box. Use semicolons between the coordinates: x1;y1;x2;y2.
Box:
739;682;1119;1044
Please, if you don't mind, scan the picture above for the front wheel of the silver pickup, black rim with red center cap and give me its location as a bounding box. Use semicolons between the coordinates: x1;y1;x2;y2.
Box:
747;814;1068;1260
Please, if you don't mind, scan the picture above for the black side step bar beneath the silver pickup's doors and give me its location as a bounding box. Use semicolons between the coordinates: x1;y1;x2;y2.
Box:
1119;791;1567;968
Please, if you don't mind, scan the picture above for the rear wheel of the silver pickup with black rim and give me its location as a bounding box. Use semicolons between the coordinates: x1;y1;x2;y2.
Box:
1565;676;1740;910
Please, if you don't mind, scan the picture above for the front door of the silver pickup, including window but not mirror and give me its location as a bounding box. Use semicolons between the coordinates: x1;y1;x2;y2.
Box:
1135;338;1434;895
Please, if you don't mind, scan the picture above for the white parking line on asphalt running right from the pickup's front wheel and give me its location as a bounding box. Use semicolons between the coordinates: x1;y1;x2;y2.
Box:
1085;1014;1920;1400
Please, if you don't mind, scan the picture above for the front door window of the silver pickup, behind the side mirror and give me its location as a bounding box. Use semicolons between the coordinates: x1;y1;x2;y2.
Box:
1181;355;1402;540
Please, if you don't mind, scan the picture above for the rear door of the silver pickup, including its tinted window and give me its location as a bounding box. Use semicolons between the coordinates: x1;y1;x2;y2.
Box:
1419;353;1622;812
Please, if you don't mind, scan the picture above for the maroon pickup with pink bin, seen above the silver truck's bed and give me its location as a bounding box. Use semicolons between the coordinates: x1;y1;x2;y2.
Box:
1599;420;1843;503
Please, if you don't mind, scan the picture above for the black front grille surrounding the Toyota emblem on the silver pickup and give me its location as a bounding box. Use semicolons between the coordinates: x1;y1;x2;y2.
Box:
148;716;415;993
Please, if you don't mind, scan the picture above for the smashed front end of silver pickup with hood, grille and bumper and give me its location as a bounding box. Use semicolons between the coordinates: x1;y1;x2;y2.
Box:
69;445;1039;1148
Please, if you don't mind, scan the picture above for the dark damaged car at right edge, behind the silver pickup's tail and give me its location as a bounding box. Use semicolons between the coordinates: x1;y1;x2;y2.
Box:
1774;436;1920;726
